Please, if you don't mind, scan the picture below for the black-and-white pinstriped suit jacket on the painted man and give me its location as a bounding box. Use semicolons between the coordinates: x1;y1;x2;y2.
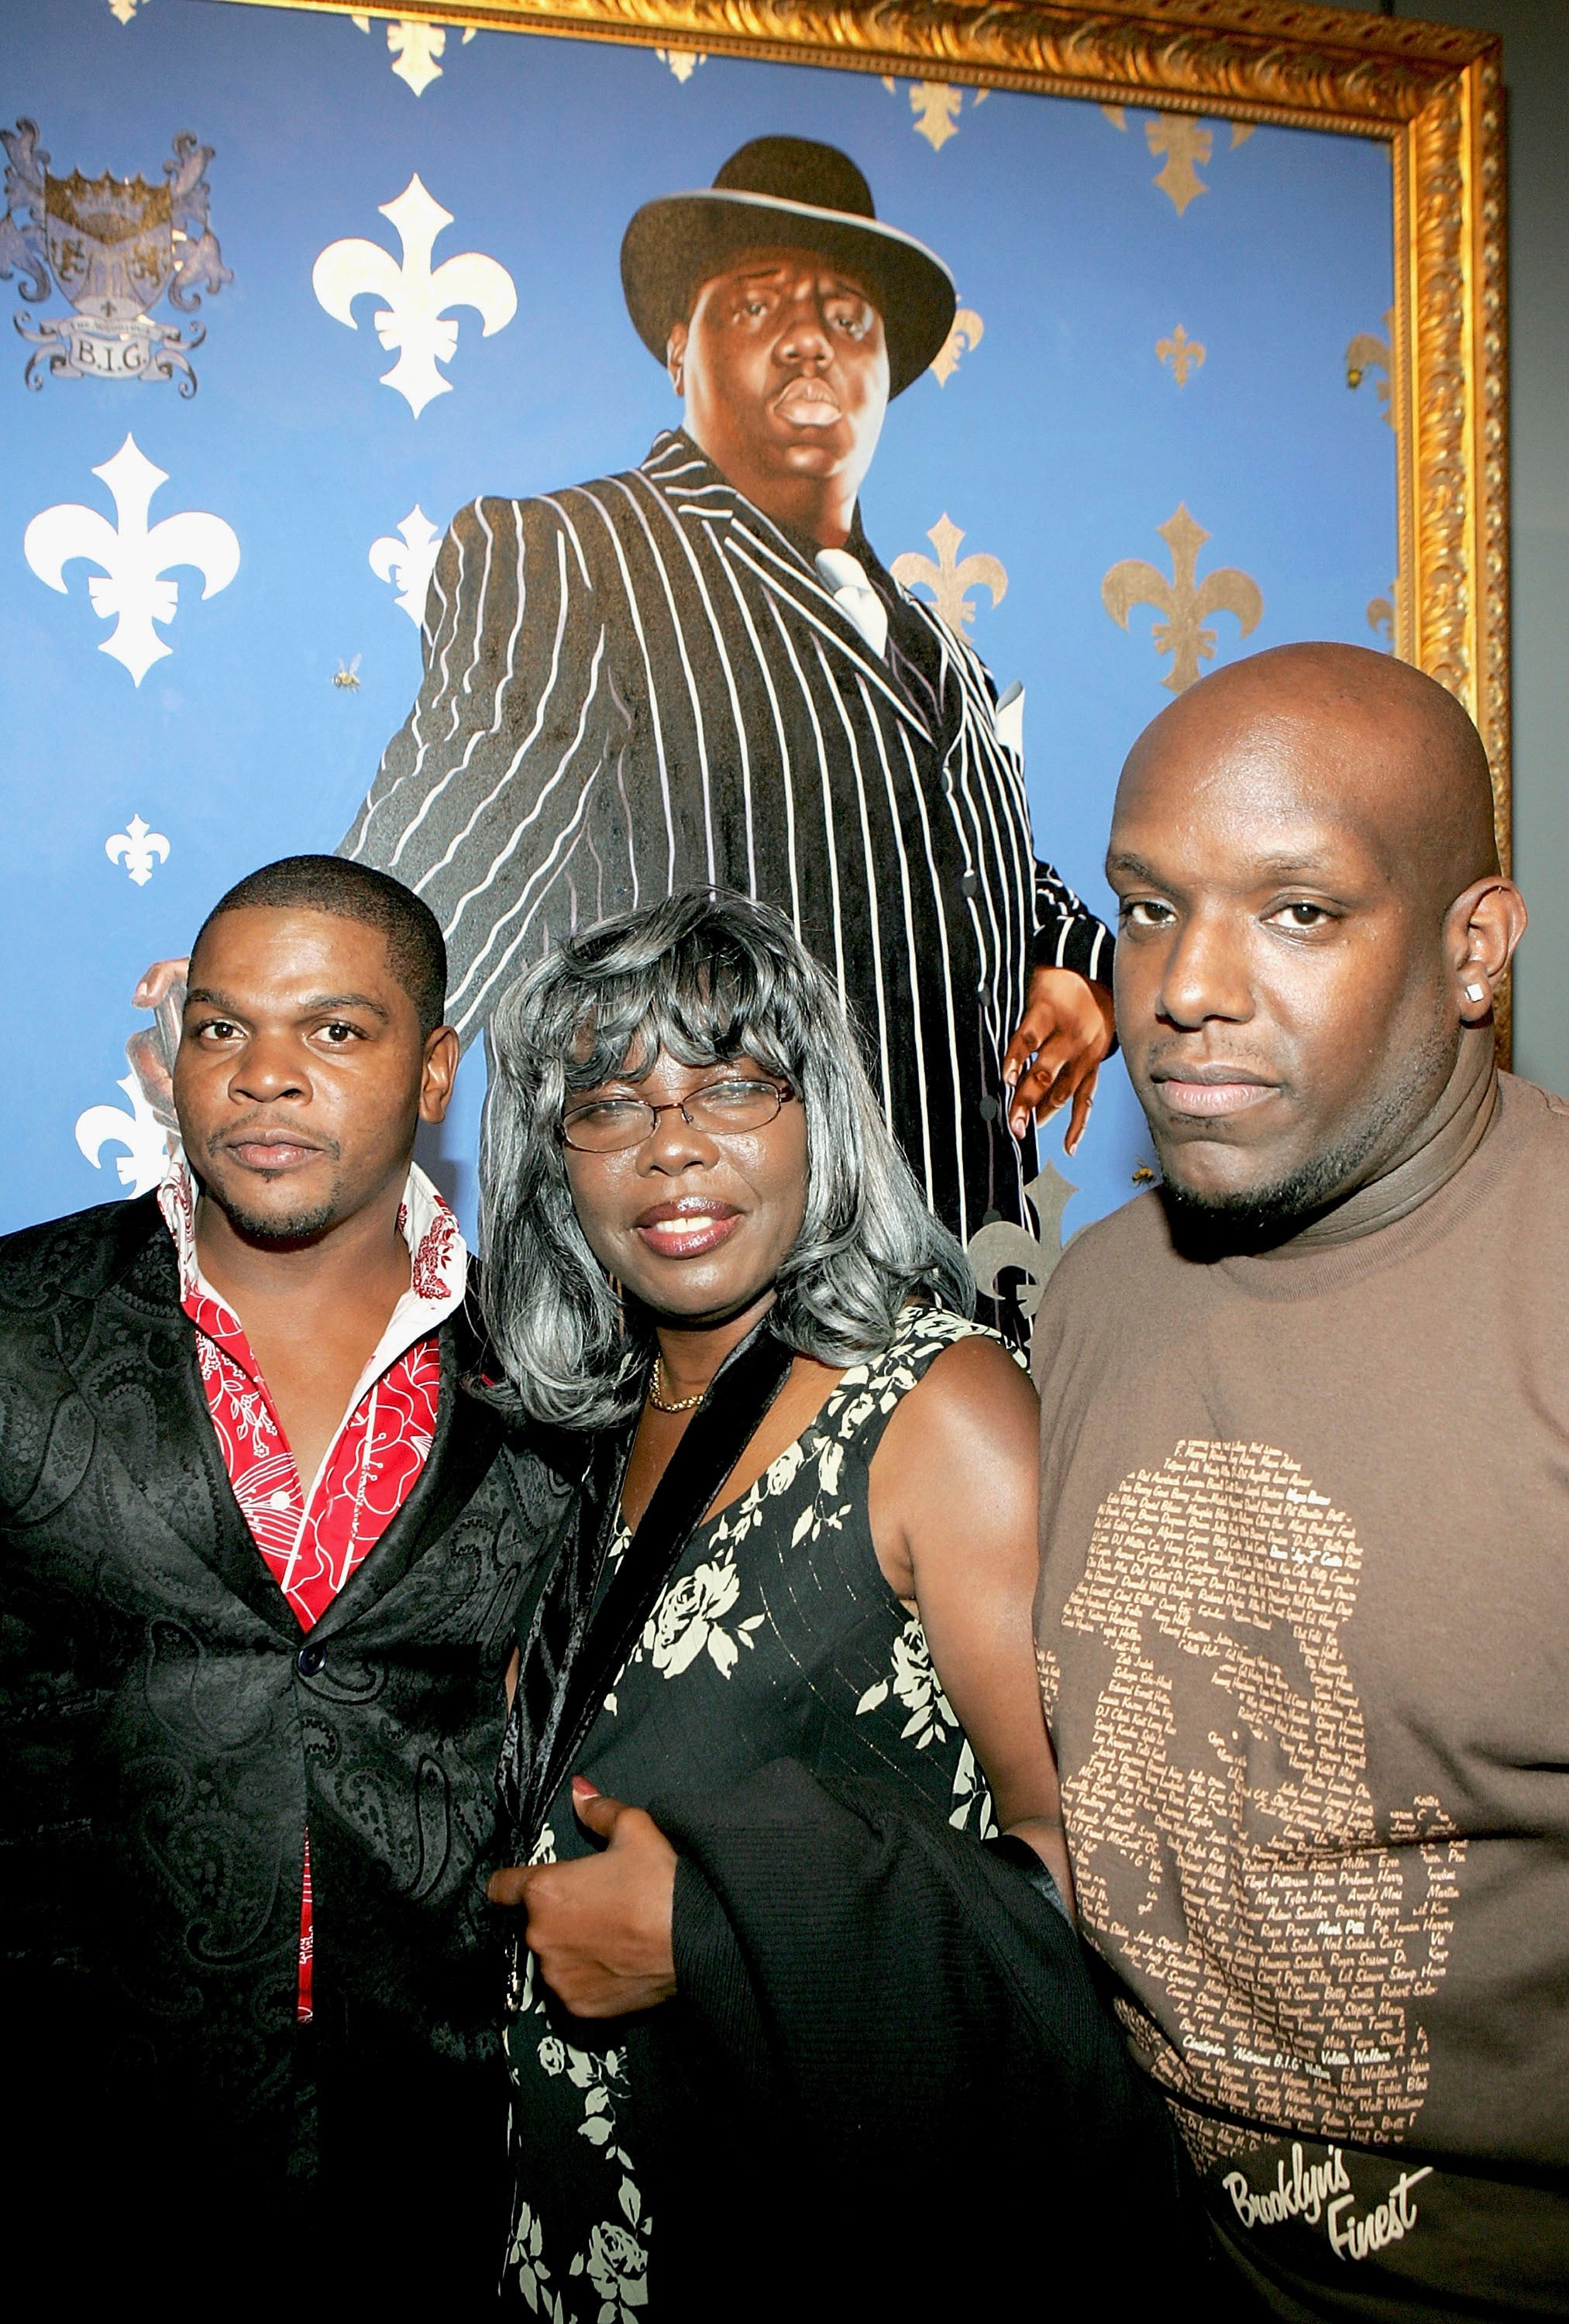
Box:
342;432;1111;1239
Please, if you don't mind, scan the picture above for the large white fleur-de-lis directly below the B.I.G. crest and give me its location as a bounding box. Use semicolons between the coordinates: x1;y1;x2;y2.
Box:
21;437;239;686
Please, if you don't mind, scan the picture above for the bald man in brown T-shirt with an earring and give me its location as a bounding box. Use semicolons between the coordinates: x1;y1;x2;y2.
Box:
1037;646;1569;2319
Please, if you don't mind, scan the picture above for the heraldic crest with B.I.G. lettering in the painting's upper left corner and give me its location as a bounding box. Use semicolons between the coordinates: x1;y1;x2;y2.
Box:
0;121;235;395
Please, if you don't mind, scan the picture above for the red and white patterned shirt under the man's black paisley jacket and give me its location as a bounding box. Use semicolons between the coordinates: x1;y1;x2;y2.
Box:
158;1157;467;2024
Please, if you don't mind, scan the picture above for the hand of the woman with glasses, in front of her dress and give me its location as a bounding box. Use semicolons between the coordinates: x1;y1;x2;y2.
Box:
486;1776;676;2017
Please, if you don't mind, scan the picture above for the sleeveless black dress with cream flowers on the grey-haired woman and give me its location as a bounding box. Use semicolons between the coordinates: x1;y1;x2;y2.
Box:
504;1308;1013;2324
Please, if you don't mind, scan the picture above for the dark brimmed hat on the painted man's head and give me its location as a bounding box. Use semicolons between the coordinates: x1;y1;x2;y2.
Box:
621;137;955;395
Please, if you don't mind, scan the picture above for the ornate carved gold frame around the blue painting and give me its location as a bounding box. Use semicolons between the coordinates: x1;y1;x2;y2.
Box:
230;0;1511;1018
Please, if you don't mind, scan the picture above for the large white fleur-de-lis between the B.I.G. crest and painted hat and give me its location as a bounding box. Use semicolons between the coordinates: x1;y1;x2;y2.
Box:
311;177;518;418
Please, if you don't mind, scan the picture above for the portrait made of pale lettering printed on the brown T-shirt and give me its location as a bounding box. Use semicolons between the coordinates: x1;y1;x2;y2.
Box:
1041;1441;1467;2161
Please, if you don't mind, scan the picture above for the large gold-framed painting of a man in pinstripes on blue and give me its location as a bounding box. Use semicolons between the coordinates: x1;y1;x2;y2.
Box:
0;0;1509;1306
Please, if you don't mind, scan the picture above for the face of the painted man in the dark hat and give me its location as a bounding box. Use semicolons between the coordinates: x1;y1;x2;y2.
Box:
669;249;888;514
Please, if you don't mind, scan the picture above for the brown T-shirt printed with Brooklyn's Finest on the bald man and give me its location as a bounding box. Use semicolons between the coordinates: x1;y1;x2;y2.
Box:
1037;1076;1569;2319
